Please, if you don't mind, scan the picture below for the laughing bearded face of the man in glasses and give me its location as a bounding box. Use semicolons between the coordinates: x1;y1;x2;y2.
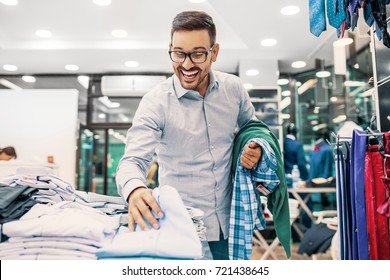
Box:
171;30;219;96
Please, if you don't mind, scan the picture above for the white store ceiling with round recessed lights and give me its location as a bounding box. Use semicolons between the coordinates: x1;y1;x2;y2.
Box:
0;0;372;74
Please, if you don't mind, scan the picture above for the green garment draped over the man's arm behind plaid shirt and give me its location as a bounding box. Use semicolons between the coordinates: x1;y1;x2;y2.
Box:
232;120;291;258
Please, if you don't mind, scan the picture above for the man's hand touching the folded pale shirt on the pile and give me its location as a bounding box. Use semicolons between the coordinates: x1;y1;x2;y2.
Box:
128;187;163;231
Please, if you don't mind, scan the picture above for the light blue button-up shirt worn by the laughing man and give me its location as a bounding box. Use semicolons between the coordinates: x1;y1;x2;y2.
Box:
116;71;256;241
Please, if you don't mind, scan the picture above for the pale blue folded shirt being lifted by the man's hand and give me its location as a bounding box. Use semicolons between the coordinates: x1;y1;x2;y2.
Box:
96;185;202;259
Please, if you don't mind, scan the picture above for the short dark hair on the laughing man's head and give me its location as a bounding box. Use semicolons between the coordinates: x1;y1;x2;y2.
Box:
171;11;217;45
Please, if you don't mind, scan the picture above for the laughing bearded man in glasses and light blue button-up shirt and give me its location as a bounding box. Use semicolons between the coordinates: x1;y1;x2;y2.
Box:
116;11;261;259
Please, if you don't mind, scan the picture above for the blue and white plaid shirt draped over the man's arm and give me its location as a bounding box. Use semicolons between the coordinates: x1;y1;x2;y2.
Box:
229;138;280;260
